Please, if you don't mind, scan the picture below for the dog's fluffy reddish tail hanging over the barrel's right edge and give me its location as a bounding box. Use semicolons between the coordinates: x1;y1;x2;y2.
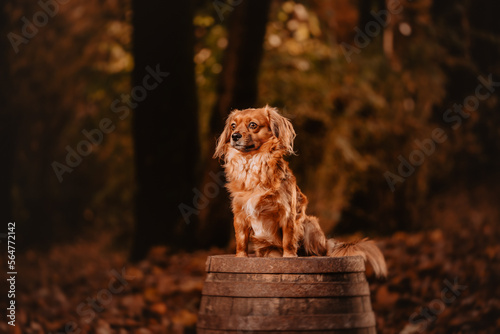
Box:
327;238;387;277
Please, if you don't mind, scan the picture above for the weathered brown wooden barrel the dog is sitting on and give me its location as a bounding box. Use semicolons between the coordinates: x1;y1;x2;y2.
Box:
197;255;376;334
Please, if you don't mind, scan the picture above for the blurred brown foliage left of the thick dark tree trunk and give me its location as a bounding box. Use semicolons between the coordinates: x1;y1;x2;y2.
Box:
7;1;133;243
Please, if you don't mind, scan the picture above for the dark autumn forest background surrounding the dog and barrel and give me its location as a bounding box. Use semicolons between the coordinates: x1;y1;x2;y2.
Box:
0;0;500;333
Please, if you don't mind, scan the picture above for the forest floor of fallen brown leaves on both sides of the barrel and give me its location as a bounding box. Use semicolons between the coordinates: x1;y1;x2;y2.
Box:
0;187;500;334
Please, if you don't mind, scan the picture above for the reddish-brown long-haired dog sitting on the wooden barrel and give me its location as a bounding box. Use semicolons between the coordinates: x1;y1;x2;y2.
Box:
213;105;387;277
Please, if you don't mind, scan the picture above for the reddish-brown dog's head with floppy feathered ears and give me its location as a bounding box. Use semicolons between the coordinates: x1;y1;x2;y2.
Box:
214;106;295;158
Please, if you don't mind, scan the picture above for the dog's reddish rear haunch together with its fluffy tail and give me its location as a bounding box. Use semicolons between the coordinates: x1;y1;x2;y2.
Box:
304;216;387;277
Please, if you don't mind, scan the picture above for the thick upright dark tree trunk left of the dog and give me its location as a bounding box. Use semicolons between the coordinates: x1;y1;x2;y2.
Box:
131;0;199;260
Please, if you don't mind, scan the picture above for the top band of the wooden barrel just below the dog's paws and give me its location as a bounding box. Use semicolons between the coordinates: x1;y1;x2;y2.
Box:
206;254;365;274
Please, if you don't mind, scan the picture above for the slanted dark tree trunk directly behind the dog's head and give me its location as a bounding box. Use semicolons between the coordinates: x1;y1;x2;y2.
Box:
198;0;270;246
